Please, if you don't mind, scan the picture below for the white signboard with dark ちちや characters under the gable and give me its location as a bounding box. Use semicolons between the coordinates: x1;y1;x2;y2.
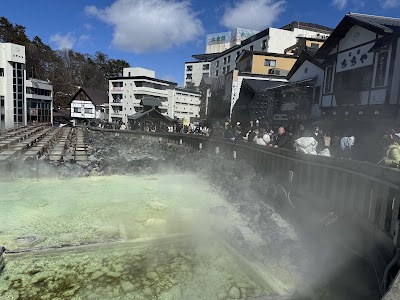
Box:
336;43;374;73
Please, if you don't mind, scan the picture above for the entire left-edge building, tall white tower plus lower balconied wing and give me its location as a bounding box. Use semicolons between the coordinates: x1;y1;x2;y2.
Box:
0;43;53;129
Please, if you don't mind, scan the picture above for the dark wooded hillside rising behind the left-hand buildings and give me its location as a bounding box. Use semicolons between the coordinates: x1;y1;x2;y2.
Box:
0;17;129;107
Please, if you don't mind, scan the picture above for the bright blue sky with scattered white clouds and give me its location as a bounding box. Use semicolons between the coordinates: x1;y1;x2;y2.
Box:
0;0;400;85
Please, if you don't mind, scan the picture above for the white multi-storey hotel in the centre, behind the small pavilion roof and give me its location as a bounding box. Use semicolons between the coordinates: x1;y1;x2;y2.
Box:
108;68;200;123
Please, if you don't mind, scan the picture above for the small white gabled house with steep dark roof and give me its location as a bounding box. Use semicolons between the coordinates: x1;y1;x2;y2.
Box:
70;88;108;126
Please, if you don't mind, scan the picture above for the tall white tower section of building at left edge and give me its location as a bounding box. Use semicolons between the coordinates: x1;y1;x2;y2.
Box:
0;43;27;129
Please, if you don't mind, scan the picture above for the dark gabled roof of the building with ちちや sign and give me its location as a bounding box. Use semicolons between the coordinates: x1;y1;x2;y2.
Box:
316;13;400;58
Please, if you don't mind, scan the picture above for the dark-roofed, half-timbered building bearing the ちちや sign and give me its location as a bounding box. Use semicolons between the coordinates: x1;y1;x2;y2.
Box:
316;13;400;129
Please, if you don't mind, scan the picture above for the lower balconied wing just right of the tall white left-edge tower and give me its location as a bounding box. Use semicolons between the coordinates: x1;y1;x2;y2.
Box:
25;78;53;123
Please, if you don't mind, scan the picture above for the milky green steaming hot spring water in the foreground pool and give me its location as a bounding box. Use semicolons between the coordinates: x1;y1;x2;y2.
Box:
0;174;271;299
